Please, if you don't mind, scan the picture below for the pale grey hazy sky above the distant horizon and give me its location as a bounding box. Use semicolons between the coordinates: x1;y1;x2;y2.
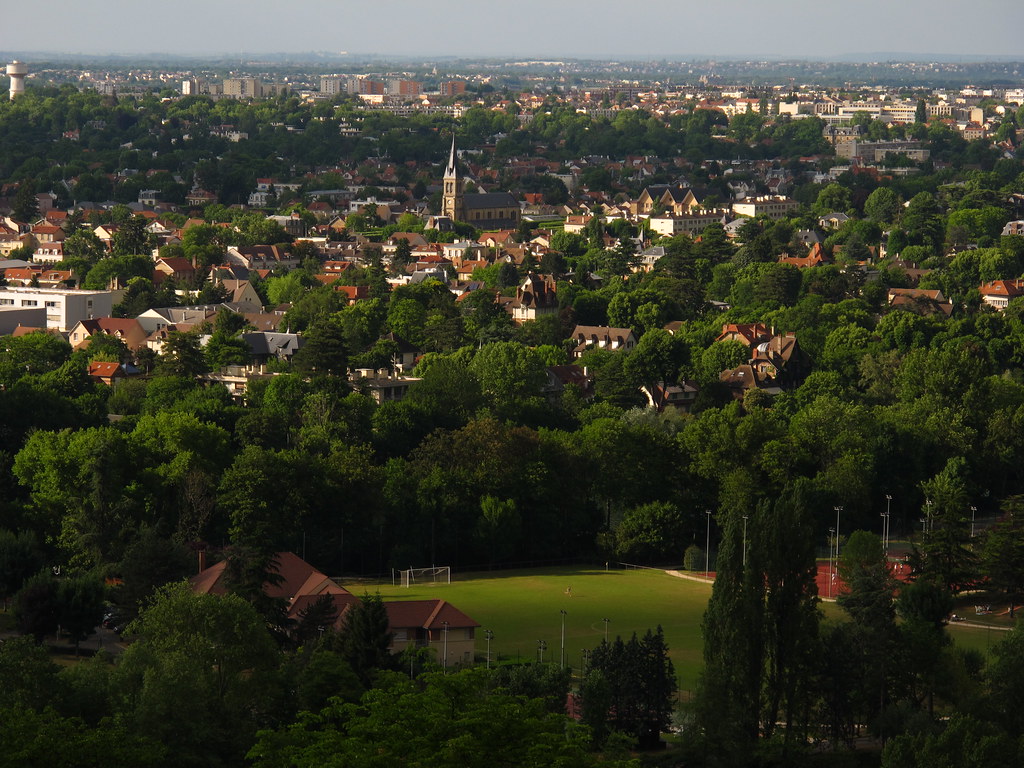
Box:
0;0;1024;59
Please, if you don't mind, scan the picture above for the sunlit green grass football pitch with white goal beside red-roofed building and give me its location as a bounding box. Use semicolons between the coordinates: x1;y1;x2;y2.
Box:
343;567;711;695
